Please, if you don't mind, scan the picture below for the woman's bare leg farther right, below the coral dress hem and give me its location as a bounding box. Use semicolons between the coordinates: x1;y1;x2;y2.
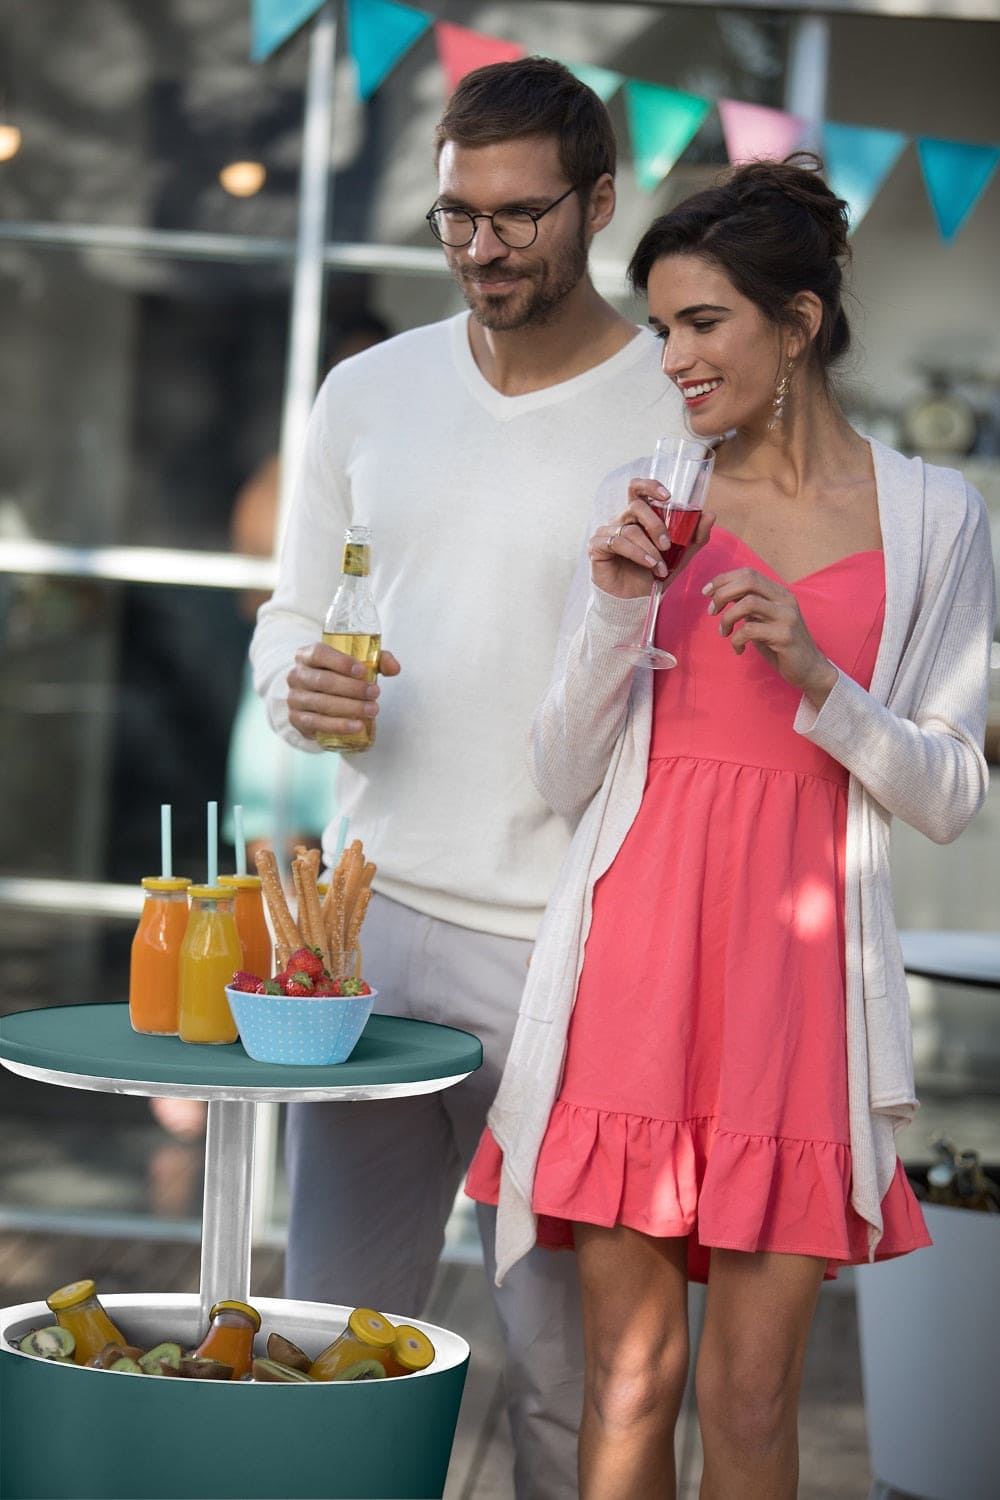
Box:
696;1250;826;1500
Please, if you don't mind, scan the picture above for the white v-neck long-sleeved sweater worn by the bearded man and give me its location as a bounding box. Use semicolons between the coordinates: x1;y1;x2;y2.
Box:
250;314;682;938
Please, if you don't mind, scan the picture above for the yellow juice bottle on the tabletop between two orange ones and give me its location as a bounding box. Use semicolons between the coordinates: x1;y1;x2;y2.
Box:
177;885;243;1043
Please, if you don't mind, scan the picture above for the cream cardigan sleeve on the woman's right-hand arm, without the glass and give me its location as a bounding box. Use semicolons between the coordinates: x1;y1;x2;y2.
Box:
795;491;996;843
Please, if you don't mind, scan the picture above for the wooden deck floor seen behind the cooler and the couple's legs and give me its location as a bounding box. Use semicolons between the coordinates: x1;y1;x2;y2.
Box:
0;1232;870;1500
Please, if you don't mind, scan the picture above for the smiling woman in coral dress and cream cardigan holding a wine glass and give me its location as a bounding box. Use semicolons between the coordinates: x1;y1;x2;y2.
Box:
468;156;994;1500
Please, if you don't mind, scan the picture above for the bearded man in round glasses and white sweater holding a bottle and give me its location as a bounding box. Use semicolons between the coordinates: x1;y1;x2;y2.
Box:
252;57;681;1500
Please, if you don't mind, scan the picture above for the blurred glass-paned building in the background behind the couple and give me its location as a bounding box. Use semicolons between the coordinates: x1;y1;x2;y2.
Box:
0;0;1000;1233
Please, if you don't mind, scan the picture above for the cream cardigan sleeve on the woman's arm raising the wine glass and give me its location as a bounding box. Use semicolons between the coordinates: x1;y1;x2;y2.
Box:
528;461;646;818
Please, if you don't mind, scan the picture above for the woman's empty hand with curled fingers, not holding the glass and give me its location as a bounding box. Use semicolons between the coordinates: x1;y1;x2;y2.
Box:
702;567;840;708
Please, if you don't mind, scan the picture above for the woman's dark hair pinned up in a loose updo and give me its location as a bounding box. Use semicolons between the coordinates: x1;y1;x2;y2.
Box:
628;152;850;372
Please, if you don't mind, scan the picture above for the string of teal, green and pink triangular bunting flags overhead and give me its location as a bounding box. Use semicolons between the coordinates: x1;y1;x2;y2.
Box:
250;0;1000;242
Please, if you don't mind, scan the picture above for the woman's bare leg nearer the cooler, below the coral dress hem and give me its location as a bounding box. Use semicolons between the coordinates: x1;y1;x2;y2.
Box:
574;1224;688;1500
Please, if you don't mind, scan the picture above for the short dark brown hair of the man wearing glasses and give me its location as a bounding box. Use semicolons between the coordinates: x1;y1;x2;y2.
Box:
435;57;616;192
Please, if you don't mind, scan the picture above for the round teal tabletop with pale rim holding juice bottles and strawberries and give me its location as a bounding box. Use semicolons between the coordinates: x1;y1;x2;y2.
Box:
0;1004;483;1101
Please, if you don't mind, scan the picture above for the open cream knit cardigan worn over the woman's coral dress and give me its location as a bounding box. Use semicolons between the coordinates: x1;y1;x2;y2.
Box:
489;441;994;1284
